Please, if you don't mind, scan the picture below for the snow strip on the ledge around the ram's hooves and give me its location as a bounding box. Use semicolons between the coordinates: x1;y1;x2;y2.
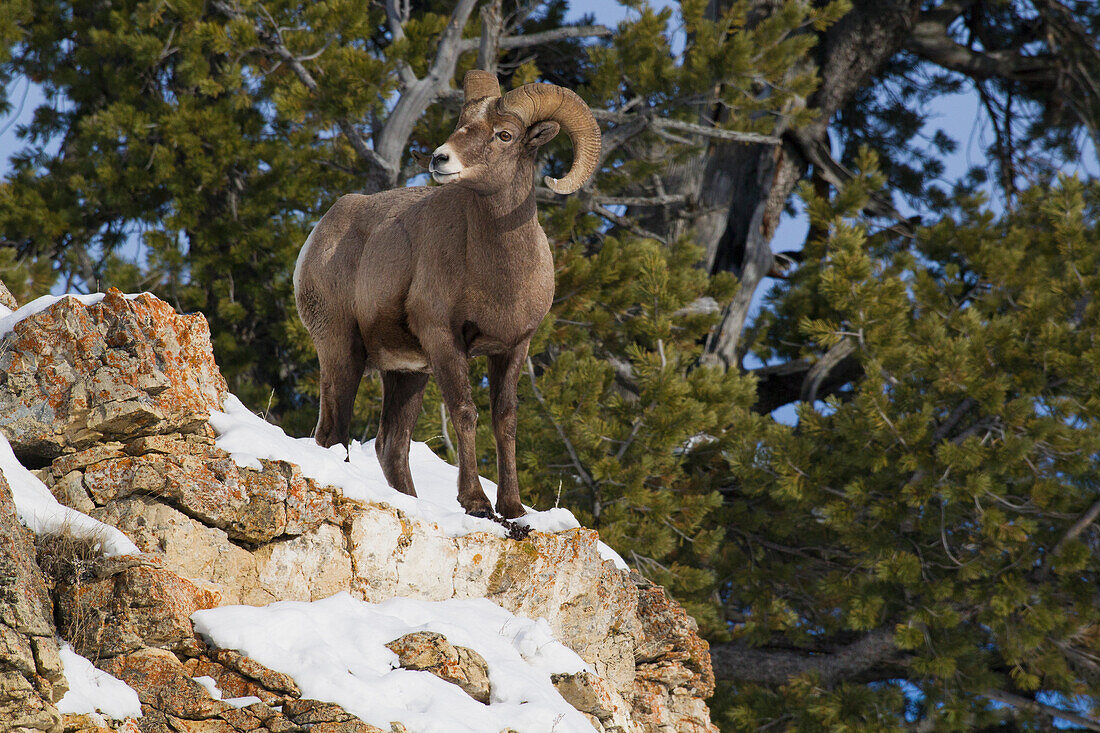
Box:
210;395;627;570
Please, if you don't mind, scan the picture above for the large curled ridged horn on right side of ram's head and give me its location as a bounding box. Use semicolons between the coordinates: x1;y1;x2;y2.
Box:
499;82;600;194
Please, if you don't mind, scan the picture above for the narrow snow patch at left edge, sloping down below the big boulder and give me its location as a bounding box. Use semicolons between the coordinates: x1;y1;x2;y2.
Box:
0;433;140;556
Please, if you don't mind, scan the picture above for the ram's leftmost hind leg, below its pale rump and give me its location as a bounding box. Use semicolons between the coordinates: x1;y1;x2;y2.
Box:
314;325;366;448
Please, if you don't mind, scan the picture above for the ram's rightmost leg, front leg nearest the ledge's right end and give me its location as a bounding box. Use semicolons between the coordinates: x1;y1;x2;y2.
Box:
488;341;529;519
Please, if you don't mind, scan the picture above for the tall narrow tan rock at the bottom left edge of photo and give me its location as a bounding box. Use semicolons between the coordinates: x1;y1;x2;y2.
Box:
0;464;68;733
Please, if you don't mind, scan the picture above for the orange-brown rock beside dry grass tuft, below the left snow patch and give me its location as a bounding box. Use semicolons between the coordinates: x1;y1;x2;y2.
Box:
55;557;221;659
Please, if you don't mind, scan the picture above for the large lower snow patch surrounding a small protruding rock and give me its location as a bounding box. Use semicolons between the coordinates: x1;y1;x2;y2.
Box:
191;593;592;733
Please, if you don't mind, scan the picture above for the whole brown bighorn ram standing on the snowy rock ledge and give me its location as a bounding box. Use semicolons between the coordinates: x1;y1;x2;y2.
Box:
294;72;600;518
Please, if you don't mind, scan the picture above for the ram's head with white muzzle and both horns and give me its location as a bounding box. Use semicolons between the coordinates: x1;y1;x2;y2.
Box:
429;72;600;194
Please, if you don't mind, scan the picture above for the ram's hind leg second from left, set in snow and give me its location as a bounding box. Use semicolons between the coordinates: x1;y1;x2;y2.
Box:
374;372;428;496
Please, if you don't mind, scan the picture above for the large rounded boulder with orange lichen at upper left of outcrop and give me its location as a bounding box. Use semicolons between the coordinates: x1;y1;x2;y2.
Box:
0;288;227;459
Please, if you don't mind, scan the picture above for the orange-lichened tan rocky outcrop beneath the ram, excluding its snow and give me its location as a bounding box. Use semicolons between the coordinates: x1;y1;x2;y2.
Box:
0;292;716;733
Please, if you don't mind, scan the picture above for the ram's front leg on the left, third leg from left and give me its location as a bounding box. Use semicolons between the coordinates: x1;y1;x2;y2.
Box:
421;333;493;516
